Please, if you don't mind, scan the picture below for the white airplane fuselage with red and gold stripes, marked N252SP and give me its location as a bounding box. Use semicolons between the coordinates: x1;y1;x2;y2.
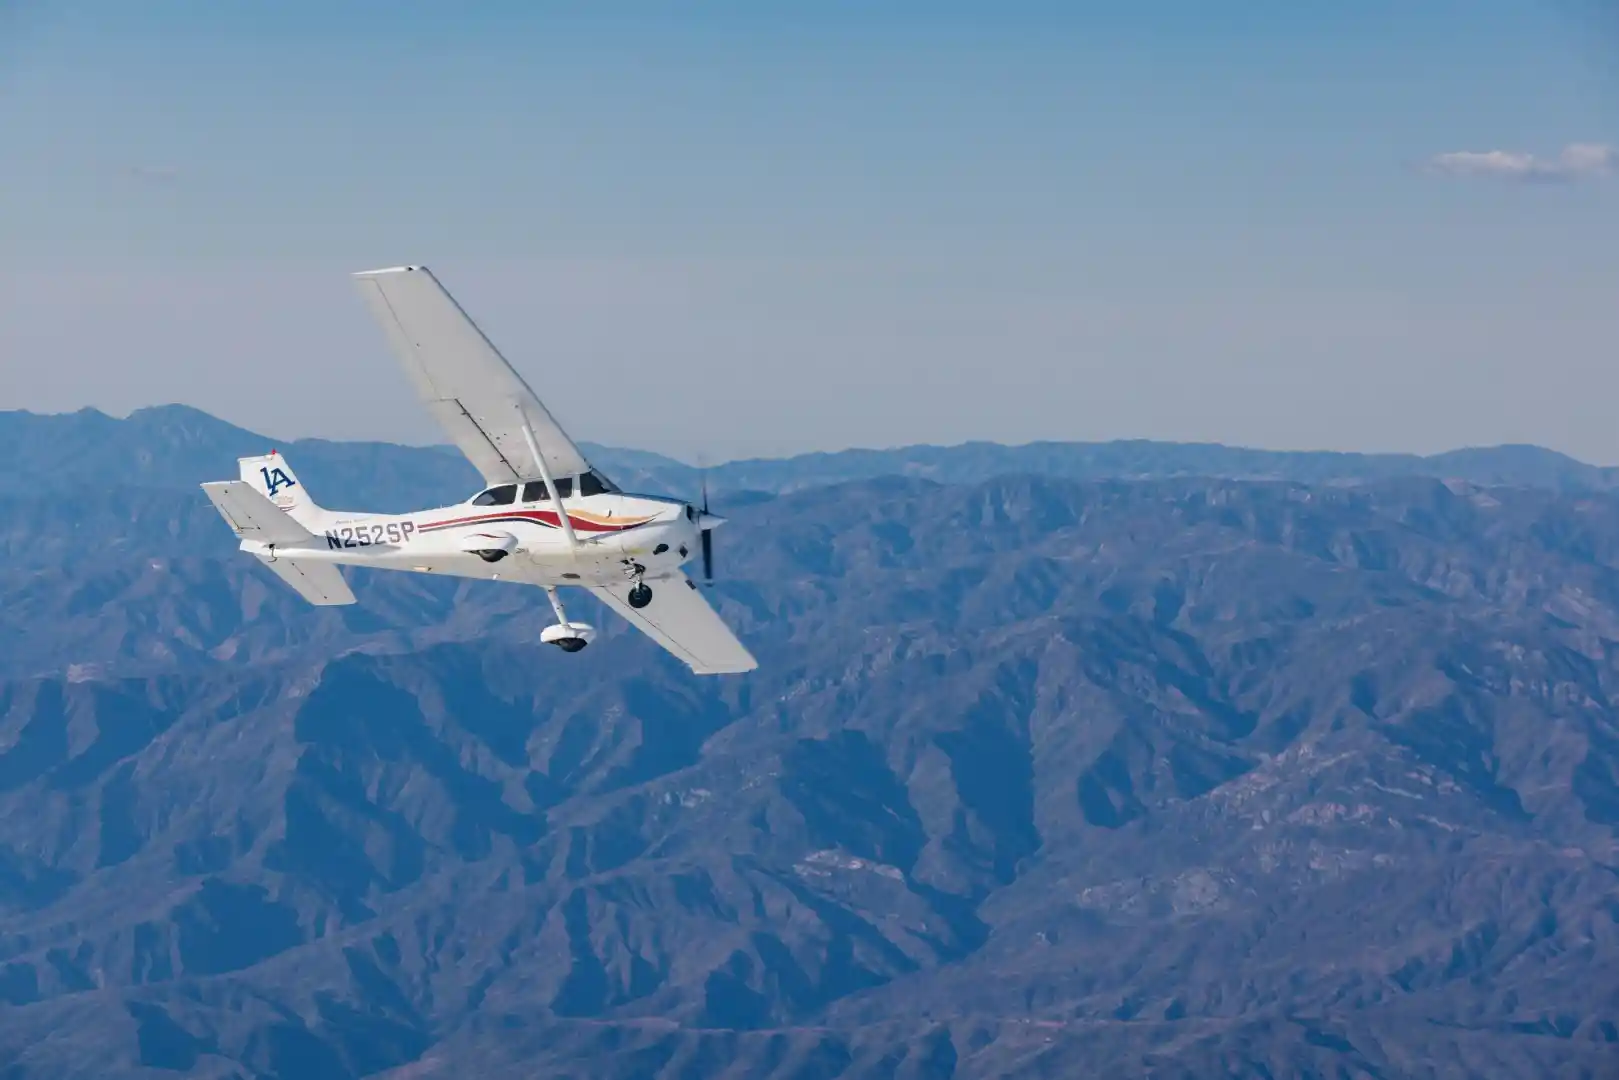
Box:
243;492;701;586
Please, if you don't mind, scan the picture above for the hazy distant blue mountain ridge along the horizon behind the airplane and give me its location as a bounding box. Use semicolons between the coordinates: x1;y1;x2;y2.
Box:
0;405;1619;508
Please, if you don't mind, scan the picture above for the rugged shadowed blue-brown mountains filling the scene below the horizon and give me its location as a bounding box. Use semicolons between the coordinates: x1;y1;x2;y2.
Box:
0;410;1619;1080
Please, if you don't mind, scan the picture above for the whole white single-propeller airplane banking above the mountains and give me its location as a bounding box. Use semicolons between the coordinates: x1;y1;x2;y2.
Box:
202;266;758;675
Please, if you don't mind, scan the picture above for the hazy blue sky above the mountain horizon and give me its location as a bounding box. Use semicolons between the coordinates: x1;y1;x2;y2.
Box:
0;0;1619;463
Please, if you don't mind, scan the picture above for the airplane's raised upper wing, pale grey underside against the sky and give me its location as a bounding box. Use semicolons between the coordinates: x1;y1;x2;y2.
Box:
355;266;589;484
